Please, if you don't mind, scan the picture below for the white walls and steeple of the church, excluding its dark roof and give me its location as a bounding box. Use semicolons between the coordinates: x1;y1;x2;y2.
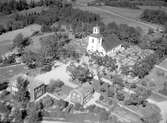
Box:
87;26;124;56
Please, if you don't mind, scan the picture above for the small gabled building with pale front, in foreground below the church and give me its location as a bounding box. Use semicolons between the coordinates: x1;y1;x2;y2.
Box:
69;83;94;105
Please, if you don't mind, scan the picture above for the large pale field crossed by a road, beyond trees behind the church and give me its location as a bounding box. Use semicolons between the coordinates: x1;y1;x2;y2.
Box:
76;6;159;32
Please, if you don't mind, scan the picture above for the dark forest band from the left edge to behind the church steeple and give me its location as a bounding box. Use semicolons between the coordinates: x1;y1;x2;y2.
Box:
0;4;100;34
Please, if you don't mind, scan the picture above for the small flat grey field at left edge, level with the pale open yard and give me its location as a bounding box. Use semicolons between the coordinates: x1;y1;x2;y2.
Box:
0;64;26;82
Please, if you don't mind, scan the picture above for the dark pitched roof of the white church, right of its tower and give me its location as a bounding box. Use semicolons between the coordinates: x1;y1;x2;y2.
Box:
102;34;122;52
